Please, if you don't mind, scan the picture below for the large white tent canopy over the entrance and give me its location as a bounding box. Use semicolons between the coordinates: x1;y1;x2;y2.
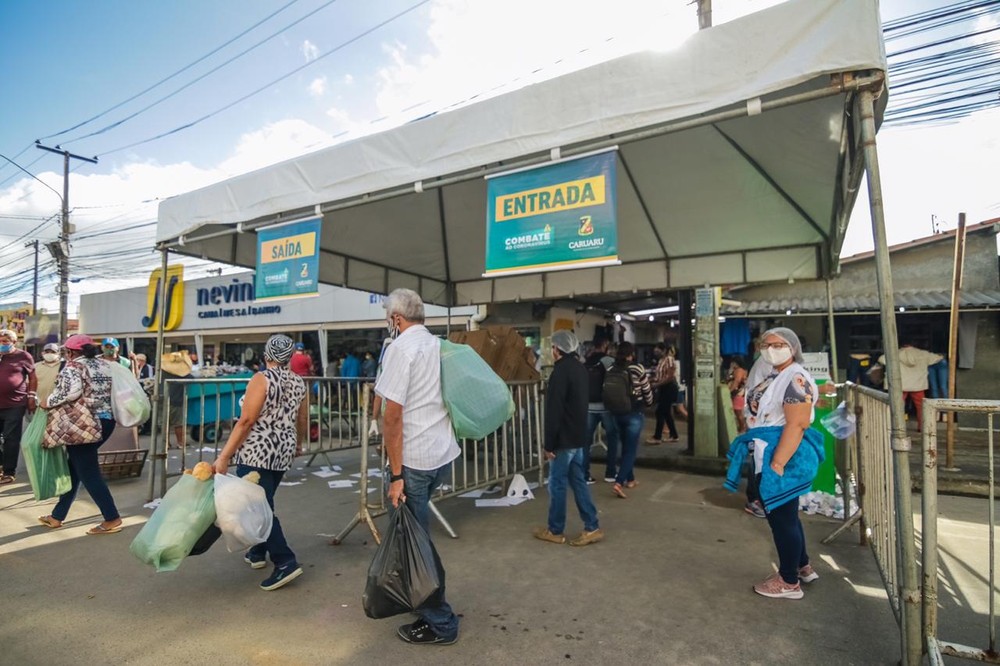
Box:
157;0;886;305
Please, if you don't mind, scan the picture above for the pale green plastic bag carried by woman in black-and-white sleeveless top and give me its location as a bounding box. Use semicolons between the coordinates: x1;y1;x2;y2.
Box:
128;474;215;571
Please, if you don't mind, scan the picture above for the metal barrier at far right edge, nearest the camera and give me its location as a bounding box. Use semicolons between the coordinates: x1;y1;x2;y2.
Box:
921;399;1000;664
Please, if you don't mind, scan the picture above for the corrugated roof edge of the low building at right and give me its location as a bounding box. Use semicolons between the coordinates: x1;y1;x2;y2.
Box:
720;289;1000;315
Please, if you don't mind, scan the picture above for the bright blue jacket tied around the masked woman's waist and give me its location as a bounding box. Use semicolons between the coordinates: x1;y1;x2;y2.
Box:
723;426;826;511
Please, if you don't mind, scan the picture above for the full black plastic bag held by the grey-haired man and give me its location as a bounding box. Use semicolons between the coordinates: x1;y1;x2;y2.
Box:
361;502;444;619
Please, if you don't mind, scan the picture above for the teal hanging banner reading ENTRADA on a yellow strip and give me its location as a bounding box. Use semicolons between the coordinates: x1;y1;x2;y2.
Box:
483;149;621;277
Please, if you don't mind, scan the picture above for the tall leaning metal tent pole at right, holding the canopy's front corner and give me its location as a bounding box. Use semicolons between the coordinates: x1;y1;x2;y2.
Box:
857;88;922;666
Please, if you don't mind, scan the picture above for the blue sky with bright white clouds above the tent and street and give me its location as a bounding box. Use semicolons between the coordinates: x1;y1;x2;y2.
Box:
0;0;1000;312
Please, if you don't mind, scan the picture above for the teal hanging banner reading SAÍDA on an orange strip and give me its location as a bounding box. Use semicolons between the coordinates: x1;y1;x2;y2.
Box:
254;217;323;301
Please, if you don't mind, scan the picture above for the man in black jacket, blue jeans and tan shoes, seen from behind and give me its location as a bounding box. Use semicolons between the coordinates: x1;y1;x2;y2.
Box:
534;331;604;546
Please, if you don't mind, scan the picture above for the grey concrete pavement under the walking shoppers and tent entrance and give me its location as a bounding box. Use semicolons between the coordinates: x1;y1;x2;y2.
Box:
0;440;899;666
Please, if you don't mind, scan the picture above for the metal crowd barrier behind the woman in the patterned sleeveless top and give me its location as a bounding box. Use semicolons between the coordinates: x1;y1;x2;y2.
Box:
149;377;372;500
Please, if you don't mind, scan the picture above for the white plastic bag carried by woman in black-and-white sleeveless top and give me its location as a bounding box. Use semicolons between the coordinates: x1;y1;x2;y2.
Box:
215;474;274;553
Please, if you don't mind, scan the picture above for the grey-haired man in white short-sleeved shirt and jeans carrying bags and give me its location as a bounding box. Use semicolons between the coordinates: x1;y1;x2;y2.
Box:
375;289;461;645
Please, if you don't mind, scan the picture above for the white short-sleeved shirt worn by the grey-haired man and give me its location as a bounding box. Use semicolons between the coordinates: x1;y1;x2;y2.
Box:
375;324;461;471
